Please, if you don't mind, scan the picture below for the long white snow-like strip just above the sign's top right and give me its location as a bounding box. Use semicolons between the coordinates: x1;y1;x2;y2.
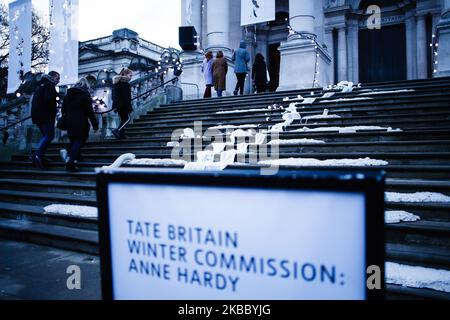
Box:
259;158;389;167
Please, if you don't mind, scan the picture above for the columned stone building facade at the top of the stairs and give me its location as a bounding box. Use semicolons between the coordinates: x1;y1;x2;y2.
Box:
181;0;450;93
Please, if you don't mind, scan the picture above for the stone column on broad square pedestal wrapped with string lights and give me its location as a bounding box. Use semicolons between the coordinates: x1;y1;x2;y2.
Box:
278;0;331;91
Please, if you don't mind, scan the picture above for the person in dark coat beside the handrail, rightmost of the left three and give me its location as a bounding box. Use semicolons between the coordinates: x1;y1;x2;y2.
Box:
112;68;133;139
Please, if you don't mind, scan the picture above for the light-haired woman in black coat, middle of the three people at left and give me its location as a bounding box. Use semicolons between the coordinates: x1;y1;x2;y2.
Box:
62;78;98;172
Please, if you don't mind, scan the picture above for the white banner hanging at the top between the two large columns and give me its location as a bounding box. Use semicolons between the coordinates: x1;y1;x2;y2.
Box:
241;0;275;26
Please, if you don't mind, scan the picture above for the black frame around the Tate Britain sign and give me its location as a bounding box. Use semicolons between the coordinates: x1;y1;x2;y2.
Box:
97;168;386;300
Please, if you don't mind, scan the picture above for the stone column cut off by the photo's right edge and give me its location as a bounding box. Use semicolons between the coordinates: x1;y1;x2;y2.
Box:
435;0;450;77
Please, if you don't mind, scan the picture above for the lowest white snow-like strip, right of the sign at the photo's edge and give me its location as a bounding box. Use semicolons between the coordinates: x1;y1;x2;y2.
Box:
386;262;450;292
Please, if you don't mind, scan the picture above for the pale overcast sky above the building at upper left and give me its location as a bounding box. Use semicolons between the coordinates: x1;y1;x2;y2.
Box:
0;0;181;48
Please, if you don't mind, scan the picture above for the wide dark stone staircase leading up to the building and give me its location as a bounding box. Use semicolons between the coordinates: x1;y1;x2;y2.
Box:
0;78;450;299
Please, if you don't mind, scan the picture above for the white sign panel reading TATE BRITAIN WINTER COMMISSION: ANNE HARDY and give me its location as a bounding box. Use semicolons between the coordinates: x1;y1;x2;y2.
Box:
107;182;366;300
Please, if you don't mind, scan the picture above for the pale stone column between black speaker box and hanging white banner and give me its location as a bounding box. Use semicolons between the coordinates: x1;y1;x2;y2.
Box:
206;0;231;53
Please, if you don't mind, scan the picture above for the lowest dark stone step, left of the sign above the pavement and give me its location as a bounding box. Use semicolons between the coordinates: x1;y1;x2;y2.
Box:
0;219;99;255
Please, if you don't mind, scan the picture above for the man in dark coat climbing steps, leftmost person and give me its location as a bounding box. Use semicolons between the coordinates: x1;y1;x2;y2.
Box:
30;71;60;169
